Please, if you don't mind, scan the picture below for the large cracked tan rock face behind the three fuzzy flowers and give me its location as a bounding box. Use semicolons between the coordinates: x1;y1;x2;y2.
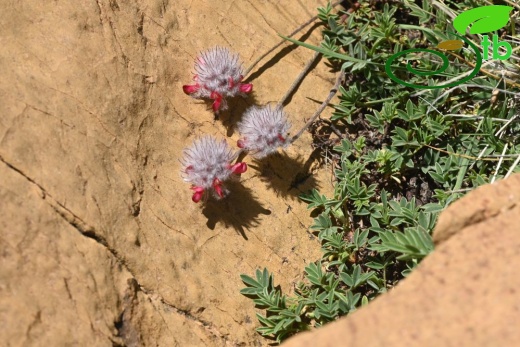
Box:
0;0;334;346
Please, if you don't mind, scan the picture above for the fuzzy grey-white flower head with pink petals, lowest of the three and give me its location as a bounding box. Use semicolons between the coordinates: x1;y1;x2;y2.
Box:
182;136;247;202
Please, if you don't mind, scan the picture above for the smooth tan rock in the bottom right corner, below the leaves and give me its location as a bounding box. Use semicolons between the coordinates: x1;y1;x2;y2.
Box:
283;174;520;347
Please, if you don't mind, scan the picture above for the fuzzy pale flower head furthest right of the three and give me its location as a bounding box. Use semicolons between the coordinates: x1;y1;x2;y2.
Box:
237;105;291;158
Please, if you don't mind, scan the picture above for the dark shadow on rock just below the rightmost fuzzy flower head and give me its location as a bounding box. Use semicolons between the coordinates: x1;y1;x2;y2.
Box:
249;153;319;199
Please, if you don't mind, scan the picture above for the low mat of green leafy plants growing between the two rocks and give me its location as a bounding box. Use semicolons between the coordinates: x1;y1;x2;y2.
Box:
241;0;520;342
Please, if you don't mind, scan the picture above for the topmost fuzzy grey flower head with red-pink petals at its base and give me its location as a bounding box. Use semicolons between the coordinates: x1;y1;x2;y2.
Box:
182;47;253;113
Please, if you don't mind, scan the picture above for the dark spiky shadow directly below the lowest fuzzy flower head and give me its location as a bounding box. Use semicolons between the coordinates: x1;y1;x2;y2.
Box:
202;181;271;240
